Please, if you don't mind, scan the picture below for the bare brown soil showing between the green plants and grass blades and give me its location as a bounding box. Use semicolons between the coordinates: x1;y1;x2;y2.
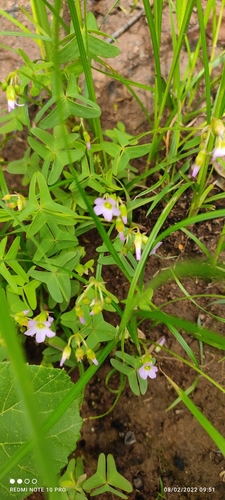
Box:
0;1;225;500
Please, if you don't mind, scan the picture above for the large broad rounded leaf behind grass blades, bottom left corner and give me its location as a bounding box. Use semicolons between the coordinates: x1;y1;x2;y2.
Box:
0;363;82;500
